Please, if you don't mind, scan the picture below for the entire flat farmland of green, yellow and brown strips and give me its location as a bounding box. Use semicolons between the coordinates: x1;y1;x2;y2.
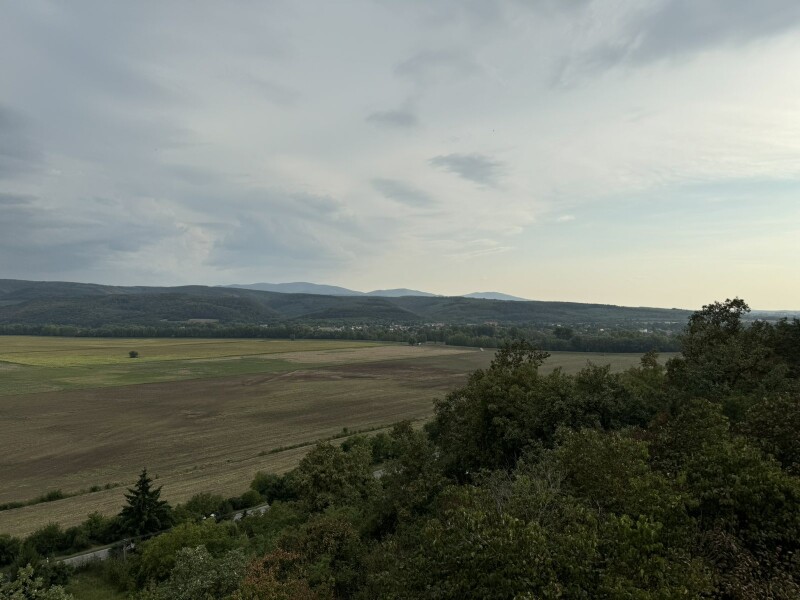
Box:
0;336;668;535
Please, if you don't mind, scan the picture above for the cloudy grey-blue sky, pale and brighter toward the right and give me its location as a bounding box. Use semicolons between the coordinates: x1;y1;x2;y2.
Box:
0;0;800;309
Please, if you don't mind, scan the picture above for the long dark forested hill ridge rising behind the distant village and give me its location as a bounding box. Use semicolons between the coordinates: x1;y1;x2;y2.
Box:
0;279;691;328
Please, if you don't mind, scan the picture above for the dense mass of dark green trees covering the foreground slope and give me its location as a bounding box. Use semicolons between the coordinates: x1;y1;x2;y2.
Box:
1;299;800;600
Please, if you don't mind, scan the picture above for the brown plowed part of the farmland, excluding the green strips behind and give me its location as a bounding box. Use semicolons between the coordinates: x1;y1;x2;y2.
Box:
0;342;656;535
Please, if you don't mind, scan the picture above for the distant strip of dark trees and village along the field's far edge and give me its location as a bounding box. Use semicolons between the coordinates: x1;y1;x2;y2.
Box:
0;323;680;353
